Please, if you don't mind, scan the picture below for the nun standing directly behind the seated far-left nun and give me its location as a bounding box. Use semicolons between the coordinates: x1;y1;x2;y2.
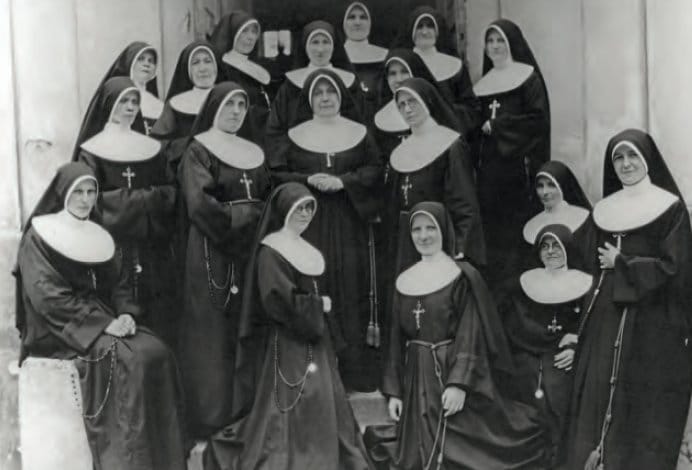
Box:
74;77;178;345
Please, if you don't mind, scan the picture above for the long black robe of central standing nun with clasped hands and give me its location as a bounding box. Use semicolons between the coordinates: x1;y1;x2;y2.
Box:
272;134;382;391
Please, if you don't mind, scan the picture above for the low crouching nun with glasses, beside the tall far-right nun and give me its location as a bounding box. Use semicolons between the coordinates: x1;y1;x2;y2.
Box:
500;224;593;468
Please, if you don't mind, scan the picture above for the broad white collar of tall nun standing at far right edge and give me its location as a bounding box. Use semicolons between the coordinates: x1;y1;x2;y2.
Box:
593;175;678;232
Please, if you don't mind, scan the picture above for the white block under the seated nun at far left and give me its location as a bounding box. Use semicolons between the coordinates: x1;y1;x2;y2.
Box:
19;357;93;470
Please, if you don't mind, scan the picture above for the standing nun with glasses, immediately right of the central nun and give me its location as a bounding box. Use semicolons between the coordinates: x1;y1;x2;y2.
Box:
385;77;486;271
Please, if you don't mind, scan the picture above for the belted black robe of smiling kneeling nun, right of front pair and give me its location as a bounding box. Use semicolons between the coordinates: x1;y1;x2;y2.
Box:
366;263;543;470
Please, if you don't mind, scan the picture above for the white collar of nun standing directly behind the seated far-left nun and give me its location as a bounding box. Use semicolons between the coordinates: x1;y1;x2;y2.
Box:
81;122;161;162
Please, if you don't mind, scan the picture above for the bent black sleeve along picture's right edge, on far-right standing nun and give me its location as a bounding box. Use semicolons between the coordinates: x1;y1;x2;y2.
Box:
613;201;692;303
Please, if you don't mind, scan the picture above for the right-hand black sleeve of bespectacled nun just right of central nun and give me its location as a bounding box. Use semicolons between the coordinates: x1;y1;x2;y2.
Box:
444;140;486;264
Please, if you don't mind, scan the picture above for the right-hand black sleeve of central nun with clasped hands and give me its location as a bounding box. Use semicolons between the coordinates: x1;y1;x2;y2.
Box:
339;132;382;220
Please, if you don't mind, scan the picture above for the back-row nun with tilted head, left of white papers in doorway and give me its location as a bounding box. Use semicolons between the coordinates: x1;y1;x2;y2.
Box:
209;10;273;137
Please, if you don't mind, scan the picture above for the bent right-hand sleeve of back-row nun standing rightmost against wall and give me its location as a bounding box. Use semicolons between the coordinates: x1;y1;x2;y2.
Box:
491;72;550;162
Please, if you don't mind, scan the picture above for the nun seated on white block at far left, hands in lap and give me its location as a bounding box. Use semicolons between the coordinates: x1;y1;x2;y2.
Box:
14;162;186;470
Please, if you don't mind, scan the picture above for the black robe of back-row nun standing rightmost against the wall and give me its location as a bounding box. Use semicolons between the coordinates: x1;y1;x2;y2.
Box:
474;71;550;285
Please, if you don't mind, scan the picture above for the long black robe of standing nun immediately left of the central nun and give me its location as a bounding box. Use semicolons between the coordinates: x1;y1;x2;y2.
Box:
178;140;271;436
